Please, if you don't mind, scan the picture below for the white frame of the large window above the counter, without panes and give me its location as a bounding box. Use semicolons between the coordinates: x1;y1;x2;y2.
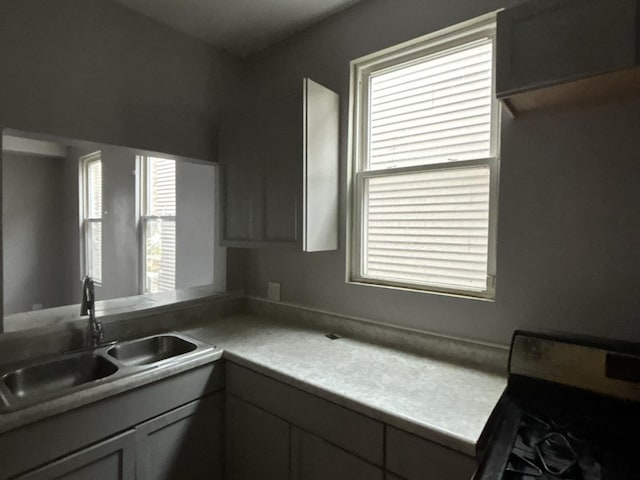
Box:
346;12;501;300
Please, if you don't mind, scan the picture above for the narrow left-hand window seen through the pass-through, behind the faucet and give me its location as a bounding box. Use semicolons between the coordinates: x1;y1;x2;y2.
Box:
80;152;102;285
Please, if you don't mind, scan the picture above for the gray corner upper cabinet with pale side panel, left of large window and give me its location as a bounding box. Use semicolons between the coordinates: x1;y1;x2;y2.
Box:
220;79;339;252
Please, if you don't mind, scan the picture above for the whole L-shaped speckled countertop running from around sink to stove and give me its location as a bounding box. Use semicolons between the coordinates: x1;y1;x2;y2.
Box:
0;307;506;456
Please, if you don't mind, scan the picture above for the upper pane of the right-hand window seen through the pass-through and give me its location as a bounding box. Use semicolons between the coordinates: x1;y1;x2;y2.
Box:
146;157;176;217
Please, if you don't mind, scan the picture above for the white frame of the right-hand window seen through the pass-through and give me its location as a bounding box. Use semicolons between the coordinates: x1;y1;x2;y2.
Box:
136;155;178;295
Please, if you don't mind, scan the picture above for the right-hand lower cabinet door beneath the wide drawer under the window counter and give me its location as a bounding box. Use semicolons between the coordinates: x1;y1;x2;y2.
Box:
291;427;384;480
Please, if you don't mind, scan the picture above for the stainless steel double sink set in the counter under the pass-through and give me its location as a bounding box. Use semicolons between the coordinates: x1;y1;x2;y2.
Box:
0;333;213;412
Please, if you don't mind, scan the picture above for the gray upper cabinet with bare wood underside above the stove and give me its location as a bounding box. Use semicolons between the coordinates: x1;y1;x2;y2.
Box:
496;0;640;113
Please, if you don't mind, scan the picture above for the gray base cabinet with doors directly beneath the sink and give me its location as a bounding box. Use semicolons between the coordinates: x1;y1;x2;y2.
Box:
0;362;224;480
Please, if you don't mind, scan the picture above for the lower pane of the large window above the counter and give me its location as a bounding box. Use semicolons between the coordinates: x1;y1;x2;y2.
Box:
363;165;490;291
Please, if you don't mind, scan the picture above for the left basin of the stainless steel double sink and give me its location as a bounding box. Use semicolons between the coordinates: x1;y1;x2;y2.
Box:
2;352;118;399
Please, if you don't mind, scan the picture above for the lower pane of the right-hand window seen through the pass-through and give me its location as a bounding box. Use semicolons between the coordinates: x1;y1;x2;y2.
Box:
144;220;176;293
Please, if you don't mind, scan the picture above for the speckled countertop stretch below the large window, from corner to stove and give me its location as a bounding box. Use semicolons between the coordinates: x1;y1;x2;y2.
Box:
184;314;506;456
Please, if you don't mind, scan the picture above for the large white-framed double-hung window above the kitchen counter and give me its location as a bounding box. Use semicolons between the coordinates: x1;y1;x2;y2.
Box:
348;15;499;298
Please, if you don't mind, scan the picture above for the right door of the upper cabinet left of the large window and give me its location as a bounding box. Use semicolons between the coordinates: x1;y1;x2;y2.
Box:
260;95;303;244
